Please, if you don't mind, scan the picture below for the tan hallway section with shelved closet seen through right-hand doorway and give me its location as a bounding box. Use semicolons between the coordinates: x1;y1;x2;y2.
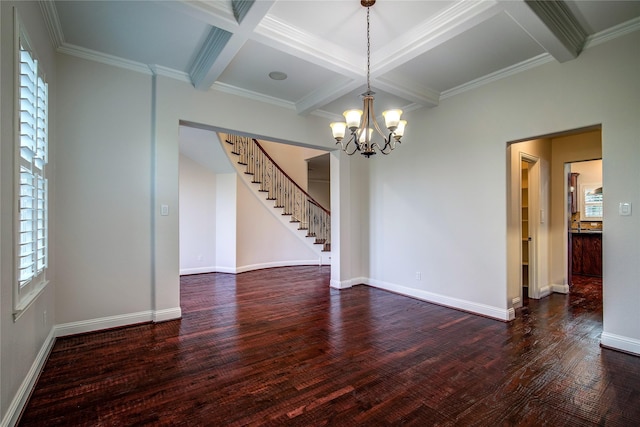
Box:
507;125;602;316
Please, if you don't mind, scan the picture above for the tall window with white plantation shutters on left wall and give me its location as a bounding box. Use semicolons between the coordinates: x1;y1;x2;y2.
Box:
14;12;49;317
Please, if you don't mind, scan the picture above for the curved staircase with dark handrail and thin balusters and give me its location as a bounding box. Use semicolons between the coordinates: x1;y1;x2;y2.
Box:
225;134;331;252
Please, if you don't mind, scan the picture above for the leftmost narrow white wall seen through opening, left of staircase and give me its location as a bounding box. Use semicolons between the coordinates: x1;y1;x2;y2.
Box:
180;155;217;274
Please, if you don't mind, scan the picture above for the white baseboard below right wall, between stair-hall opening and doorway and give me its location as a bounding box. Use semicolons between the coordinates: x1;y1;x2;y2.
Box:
367;280;515;321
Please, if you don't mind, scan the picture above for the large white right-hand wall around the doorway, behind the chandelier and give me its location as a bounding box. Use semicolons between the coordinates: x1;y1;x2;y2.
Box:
369;31;640;353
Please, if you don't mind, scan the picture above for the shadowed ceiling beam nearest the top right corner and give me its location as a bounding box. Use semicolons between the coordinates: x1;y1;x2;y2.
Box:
501;0;587;62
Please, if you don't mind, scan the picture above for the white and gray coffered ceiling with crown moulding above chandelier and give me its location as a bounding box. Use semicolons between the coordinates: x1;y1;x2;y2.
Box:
41;0;640;118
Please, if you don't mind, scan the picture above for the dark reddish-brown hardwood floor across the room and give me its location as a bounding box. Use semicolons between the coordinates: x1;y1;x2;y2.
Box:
20;267;640;426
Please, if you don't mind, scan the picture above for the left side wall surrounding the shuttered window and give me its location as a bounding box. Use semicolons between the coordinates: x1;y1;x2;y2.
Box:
0;1;59;426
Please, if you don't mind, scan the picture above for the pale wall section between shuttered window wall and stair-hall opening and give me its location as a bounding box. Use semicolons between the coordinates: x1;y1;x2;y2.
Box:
52;55;153;327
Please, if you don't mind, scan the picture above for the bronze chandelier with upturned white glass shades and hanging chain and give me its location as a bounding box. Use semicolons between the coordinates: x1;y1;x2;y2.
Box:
330;0;407;158
